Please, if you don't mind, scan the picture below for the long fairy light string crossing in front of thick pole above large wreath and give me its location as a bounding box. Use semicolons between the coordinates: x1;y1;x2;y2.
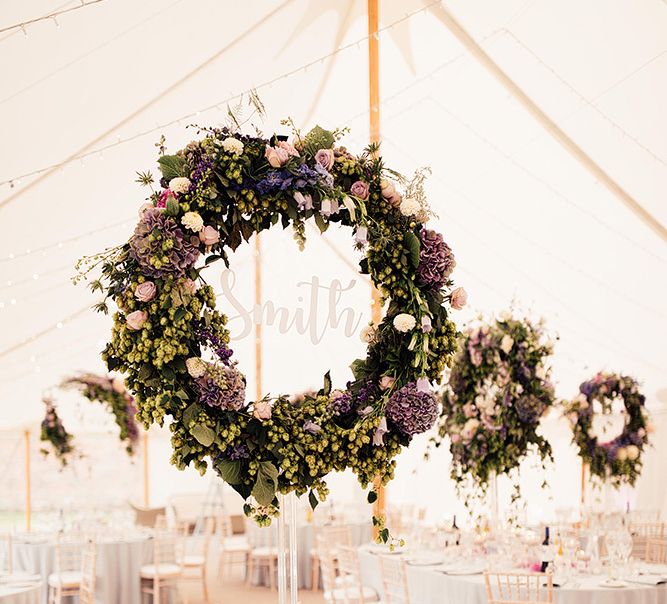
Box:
0;0;443;192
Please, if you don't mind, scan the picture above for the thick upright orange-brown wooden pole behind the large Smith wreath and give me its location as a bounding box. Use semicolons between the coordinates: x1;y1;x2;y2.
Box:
368;0;386;537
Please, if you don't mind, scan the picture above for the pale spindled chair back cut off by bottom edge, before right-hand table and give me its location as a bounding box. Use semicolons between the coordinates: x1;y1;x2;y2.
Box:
484;572;554;604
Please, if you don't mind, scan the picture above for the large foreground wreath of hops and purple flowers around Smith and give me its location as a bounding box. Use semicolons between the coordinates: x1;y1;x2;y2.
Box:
75;106;465;540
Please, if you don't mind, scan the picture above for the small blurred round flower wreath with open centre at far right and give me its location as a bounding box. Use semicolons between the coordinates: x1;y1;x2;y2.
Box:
565;372;652;487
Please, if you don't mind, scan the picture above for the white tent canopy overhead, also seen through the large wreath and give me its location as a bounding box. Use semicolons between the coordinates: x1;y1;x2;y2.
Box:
0;0;667;516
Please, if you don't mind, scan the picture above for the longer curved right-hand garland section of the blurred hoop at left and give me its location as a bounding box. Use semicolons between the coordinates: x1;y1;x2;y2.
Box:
61;373;139;455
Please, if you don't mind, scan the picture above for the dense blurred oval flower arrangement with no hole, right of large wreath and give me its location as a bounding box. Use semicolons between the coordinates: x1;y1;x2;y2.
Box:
427;312;554;493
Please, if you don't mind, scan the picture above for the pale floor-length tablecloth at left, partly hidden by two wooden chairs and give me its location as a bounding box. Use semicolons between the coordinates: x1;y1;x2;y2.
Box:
4;536;153;604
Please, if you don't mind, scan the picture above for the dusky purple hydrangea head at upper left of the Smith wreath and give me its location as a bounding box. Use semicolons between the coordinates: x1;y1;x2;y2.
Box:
130;208;199;277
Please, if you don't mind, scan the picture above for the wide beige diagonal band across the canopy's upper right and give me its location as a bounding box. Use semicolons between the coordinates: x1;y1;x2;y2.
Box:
434;0;667;242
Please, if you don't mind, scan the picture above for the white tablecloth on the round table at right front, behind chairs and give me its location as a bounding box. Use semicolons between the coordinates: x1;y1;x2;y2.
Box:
359;548;667;604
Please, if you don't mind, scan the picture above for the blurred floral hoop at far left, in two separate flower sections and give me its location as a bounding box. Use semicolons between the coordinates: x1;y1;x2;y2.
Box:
40;373;139;466
